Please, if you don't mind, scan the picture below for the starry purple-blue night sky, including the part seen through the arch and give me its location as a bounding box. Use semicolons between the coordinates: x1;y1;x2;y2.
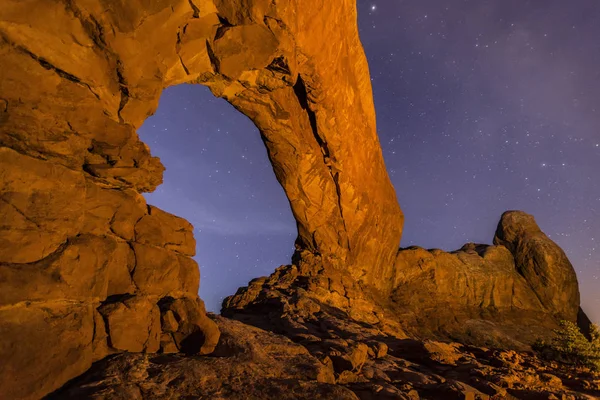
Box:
139;0;600;322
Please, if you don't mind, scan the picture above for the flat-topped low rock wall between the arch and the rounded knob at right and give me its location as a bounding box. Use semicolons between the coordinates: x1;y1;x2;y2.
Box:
391;243;557;349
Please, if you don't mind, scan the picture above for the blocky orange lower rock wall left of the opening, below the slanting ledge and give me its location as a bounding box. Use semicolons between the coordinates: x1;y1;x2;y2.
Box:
0;170;219;399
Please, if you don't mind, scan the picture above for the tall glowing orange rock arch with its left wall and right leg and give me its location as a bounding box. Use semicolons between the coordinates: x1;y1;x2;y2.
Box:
0;0;403;398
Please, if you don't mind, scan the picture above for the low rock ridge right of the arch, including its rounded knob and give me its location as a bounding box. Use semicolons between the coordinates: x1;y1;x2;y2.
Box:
391;211;585;348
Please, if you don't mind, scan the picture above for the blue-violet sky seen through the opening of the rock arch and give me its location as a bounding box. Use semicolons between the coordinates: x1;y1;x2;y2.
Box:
138;84;296;313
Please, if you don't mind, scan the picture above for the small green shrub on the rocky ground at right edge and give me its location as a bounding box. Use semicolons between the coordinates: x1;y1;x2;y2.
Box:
532;321;600;371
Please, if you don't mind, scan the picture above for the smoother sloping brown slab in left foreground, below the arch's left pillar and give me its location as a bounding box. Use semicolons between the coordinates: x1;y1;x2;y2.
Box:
48;316;357;400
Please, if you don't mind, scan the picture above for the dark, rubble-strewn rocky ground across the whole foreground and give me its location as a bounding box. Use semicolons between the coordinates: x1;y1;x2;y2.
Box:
48;312;600;400
